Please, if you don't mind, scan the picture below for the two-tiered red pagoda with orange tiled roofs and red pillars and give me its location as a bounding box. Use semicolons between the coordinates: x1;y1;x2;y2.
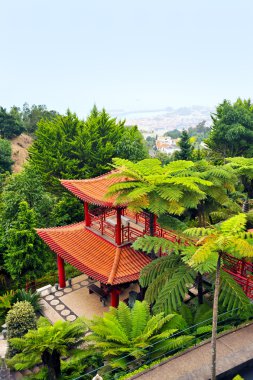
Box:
37;173;153;307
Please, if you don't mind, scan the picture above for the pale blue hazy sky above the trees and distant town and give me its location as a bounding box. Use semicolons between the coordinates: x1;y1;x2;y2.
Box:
0;0;253;116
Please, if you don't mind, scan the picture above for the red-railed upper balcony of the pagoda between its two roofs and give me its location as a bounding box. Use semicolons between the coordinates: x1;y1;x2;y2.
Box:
89;208;178;245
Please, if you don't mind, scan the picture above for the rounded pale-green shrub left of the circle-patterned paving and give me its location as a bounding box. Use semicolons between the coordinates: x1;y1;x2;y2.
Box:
5;301;37;356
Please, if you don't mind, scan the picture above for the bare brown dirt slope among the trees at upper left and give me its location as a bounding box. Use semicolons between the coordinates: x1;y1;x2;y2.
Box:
11;133;33;173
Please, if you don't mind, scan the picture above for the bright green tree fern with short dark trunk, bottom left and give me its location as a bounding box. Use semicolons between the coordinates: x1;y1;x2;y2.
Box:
8;318;86;380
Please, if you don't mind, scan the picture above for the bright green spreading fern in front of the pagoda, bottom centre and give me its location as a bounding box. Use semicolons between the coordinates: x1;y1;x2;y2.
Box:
86;301;193;368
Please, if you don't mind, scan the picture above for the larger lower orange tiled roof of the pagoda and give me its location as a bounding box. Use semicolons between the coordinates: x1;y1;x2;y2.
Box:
37;222;150;285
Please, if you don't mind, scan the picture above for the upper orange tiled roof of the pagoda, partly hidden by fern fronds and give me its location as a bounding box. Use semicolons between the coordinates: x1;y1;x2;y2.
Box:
61;172;127;207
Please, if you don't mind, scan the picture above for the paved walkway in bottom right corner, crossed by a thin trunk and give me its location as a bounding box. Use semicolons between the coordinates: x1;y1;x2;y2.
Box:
132;324;253;380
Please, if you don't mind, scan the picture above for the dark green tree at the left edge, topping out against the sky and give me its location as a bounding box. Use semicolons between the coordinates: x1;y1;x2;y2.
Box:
0;107;24;139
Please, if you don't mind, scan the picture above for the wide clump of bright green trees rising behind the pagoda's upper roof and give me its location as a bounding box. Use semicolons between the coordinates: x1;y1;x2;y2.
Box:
30;107;147;192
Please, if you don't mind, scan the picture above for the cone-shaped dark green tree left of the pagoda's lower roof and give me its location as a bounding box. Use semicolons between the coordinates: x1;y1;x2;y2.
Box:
4;202;50;284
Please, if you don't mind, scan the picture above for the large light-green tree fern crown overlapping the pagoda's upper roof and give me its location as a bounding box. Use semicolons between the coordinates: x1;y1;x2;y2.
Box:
107;158;212;215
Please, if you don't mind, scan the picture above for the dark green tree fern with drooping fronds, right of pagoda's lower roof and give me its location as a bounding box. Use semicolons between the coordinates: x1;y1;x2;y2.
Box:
133;235;249;313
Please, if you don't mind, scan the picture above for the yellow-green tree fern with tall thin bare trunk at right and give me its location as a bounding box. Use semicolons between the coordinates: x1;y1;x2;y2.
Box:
185;214;253;380
